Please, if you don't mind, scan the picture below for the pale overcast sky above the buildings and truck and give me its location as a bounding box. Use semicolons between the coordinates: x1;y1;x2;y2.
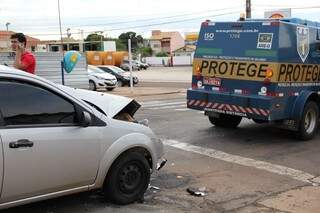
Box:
0;0;320;39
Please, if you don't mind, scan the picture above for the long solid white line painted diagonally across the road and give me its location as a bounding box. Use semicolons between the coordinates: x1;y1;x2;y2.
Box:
163;140;320;185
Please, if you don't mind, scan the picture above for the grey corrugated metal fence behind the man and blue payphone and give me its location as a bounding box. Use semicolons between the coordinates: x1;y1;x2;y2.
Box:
0;52;89;89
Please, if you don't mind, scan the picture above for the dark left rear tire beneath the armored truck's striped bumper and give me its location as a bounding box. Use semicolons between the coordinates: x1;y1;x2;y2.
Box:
209;114;242;128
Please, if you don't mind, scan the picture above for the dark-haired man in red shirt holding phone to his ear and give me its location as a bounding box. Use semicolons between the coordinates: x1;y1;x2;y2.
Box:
10;33;36;74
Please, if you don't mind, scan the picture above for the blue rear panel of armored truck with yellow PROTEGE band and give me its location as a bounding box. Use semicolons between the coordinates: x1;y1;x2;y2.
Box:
193;21;279;94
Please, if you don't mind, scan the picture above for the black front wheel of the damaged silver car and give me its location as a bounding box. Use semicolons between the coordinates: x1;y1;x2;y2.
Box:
104;152;150;205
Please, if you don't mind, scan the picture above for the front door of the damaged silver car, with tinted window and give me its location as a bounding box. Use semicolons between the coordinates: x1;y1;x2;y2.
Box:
0;80;101;203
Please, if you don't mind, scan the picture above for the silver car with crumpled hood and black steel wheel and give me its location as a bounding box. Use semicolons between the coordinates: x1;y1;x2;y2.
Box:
0;65;165;208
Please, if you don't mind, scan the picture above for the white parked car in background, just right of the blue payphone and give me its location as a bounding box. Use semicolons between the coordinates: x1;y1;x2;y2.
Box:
88;65;118;91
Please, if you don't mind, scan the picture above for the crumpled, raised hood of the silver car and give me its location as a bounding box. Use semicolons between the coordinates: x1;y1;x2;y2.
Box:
58;85;141;118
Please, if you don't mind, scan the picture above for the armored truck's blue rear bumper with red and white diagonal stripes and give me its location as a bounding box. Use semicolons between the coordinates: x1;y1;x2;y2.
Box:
187;89;273;120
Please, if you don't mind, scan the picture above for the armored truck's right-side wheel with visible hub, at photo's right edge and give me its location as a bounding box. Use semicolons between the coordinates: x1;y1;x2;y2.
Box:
297;101;319;140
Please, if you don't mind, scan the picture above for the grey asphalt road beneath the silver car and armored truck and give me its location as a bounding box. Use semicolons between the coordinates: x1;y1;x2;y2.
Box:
7;67;320;213
